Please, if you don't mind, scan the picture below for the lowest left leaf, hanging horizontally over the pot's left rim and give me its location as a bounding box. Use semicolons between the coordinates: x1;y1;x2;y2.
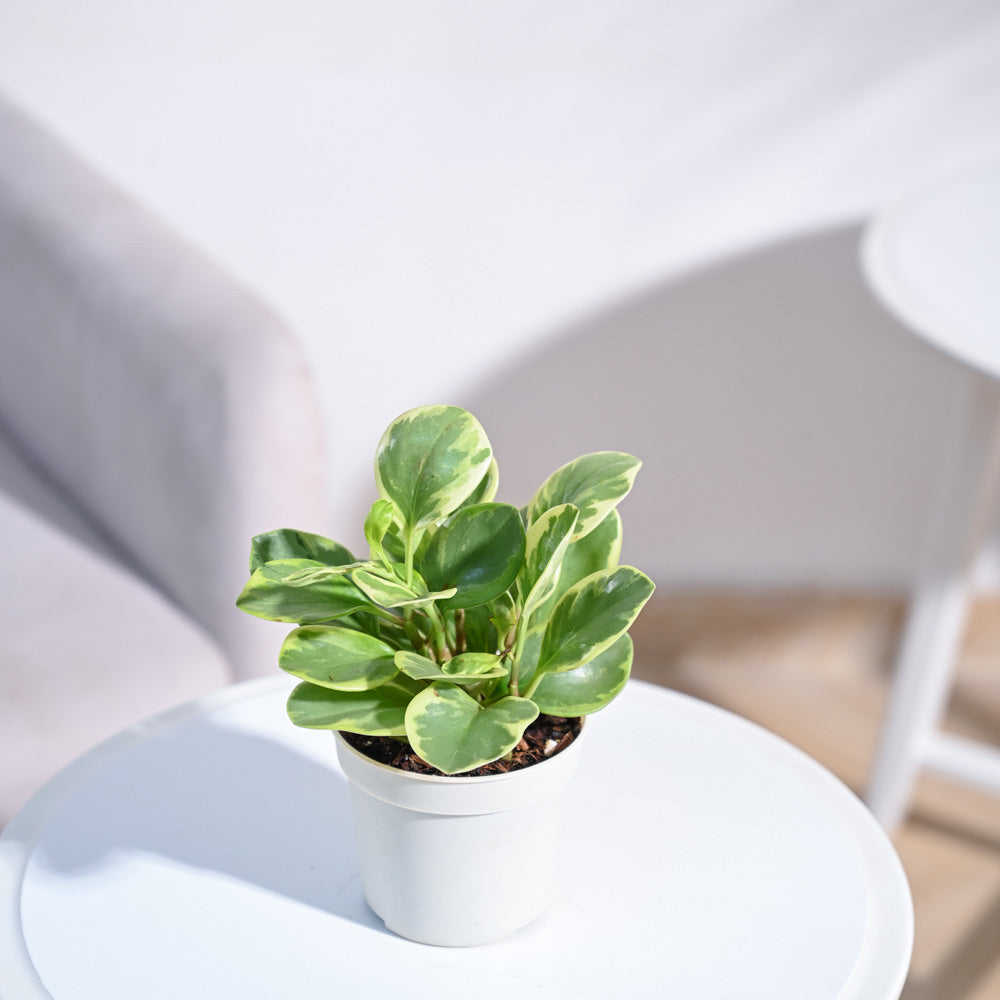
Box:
287;677;421;736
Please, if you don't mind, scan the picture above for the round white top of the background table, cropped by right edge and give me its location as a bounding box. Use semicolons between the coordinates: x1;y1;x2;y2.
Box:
862;162;1000;379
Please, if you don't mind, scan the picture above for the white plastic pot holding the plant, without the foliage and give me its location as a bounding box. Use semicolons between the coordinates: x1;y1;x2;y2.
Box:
334;725;587;946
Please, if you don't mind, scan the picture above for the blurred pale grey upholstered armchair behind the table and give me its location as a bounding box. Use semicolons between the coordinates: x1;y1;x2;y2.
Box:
0;94;325;824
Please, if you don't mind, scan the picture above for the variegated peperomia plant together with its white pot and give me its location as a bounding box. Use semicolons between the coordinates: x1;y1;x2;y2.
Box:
237;406;653;945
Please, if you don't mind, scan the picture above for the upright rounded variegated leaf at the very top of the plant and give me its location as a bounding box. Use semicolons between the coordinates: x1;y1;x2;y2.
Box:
375;406;493;532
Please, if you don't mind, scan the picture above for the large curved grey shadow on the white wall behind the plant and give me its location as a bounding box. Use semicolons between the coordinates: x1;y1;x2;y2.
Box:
465;225;988;587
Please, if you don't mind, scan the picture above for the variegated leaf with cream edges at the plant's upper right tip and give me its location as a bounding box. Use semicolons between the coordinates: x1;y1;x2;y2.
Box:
525;451;642;538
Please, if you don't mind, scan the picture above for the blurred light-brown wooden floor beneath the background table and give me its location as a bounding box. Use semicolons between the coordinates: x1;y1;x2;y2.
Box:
632;589;1000;1000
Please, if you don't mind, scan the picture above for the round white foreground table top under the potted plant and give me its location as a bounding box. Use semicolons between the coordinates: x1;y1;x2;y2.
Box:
0;677;913;1000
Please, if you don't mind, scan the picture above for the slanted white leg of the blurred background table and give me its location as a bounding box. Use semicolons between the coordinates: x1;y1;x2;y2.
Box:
868;374;1000;831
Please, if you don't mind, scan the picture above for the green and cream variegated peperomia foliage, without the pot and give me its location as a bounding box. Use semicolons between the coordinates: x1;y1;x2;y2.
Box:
237;406;653;774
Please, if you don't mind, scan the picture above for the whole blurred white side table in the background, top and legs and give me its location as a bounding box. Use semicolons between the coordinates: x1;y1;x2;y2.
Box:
862;164;1000;831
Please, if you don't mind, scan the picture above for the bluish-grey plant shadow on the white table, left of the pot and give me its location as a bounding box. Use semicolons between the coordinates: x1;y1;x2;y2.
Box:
29;724;388;933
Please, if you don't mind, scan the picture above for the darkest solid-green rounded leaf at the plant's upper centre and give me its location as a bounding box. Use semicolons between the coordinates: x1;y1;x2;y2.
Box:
420;503;525;611
